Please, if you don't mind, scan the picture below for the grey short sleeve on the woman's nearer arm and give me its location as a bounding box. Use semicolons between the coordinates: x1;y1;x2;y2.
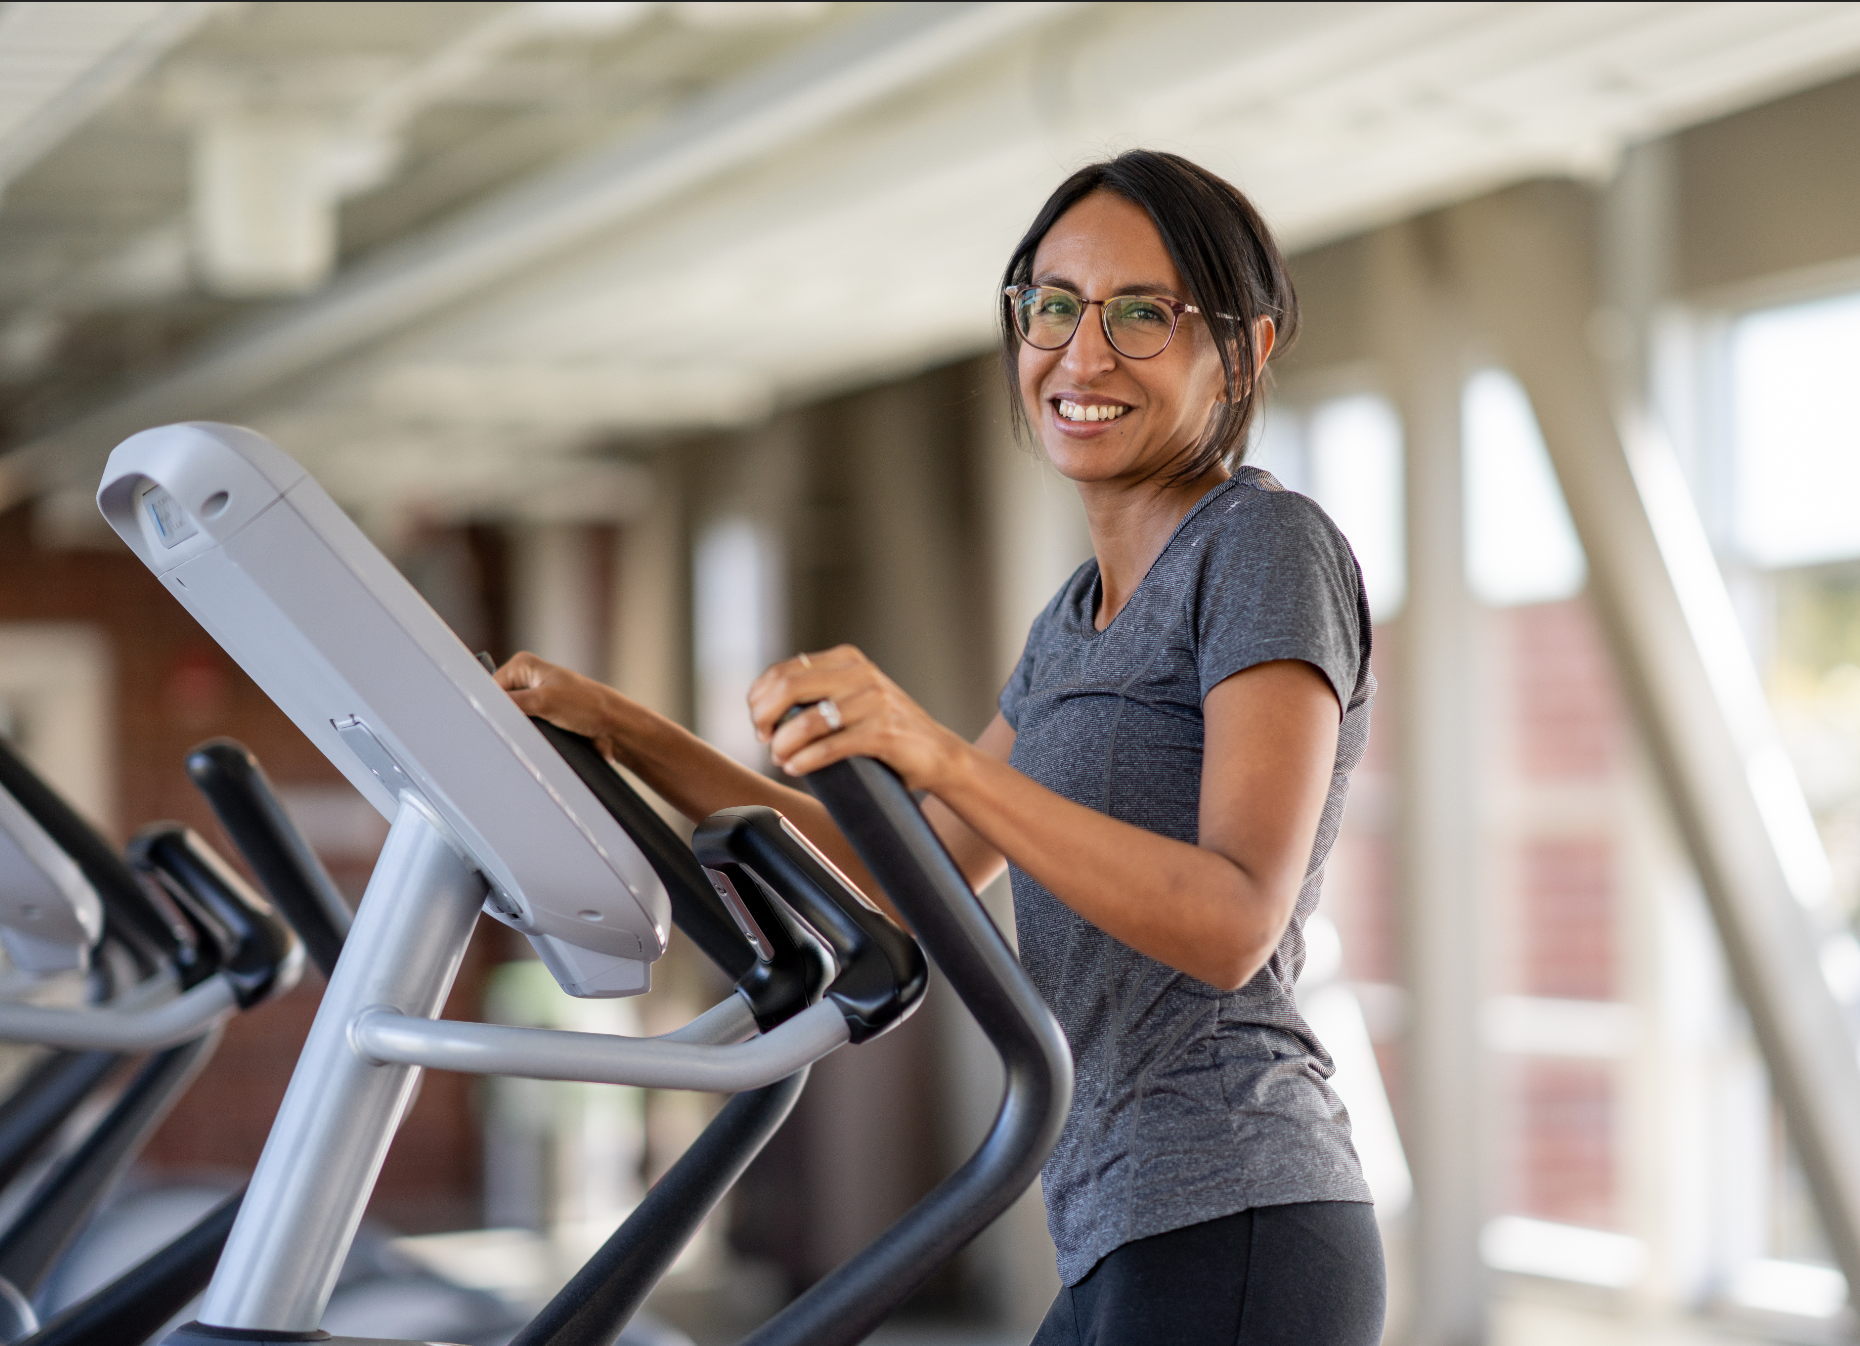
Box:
1194;478;1371;712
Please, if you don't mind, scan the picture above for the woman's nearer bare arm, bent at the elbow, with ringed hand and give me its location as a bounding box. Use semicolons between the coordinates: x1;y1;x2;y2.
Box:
750;647;1339;989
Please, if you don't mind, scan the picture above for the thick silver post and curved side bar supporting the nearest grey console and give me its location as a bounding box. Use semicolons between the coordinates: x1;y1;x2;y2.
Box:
201;796;848;1333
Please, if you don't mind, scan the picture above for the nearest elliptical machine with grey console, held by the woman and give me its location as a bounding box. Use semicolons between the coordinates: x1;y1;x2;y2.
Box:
99;424;1071;1346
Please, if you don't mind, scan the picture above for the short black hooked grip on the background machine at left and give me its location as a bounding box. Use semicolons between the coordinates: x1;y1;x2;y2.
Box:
128;822;303;1010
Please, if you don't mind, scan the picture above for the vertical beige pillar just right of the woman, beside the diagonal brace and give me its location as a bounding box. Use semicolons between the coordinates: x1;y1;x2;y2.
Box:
1375;219;1486;1346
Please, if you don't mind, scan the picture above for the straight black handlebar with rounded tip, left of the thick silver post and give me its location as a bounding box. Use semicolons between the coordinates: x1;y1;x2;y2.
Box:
188;738;350;978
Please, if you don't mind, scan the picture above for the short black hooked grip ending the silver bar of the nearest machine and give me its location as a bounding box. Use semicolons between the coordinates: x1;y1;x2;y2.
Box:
692;807;930;1043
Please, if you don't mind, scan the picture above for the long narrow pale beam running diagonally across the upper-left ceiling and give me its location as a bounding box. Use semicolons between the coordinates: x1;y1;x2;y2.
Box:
0;0;1077;509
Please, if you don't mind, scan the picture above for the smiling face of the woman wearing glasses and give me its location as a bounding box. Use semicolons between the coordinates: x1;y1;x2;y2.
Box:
1019;191;1224;483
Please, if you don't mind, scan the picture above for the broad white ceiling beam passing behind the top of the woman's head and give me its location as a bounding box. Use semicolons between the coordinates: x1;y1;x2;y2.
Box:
297;4;1860;433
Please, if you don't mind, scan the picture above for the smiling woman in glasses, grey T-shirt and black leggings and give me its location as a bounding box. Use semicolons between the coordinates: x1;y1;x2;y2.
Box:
498;151;1384;1346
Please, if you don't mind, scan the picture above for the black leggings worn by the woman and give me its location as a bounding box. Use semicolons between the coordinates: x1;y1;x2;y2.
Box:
1032;1201;1386;1346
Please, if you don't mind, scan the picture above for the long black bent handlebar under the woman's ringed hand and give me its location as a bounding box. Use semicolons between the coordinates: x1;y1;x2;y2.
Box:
744;757;1071;1346
